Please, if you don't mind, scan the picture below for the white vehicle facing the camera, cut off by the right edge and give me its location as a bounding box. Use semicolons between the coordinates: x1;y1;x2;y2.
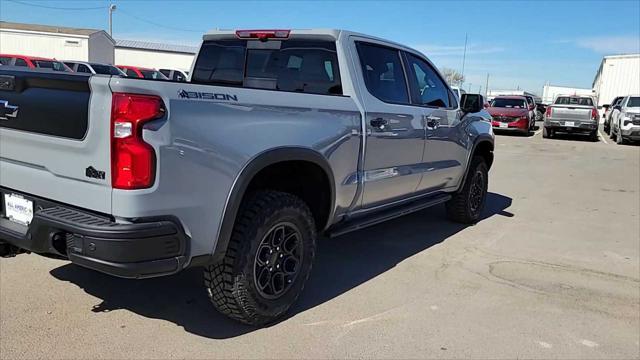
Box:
610;95;640;144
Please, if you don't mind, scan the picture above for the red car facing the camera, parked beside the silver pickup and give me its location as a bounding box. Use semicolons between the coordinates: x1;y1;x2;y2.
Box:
487;96;535;134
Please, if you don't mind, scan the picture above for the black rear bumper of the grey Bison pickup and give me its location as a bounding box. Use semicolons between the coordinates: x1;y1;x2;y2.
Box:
0;188;188;278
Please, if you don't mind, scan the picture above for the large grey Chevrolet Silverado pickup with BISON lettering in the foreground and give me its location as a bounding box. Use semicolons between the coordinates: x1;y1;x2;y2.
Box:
0;30;494;325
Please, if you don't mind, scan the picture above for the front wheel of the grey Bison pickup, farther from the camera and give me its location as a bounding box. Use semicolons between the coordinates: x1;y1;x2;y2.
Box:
446;156;489;224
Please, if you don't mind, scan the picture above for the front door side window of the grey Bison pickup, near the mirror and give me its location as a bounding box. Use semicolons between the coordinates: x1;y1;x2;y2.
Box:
407;54;450;108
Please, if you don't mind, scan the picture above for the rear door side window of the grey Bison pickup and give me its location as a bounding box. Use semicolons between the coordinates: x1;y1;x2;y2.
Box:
356;42;409;104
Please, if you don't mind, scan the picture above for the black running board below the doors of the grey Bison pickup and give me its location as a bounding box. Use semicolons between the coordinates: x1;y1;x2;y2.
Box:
326;194;451;238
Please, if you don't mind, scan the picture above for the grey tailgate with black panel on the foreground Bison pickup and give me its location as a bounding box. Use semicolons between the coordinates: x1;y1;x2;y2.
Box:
0;68;112;214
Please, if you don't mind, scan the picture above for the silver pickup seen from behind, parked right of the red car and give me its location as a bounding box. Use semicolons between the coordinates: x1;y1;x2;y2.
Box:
542;95;599;141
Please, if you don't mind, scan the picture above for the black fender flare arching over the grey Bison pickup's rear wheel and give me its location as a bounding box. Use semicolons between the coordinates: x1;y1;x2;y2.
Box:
208;147;335;262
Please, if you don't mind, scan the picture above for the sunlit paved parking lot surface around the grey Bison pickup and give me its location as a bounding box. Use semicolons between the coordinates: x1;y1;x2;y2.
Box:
0;122;640;359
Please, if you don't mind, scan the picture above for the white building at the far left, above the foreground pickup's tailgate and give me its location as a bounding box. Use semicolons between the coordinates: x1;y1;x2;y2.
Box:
0;21;115;64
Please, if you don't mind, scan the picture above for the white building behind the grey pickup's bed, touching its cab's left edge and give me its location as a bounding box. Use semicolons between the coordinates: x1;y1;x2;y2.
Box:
115;40;198;71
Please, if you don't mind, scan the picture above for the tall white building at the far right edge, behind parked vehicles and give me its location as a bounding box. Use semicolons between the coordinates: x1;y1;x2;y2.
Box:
593;54;640;107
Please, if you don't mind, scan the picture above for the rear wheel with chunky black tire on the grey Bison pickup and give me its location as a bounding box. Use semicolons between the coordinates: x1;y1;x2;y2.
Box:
204;191;316;326
